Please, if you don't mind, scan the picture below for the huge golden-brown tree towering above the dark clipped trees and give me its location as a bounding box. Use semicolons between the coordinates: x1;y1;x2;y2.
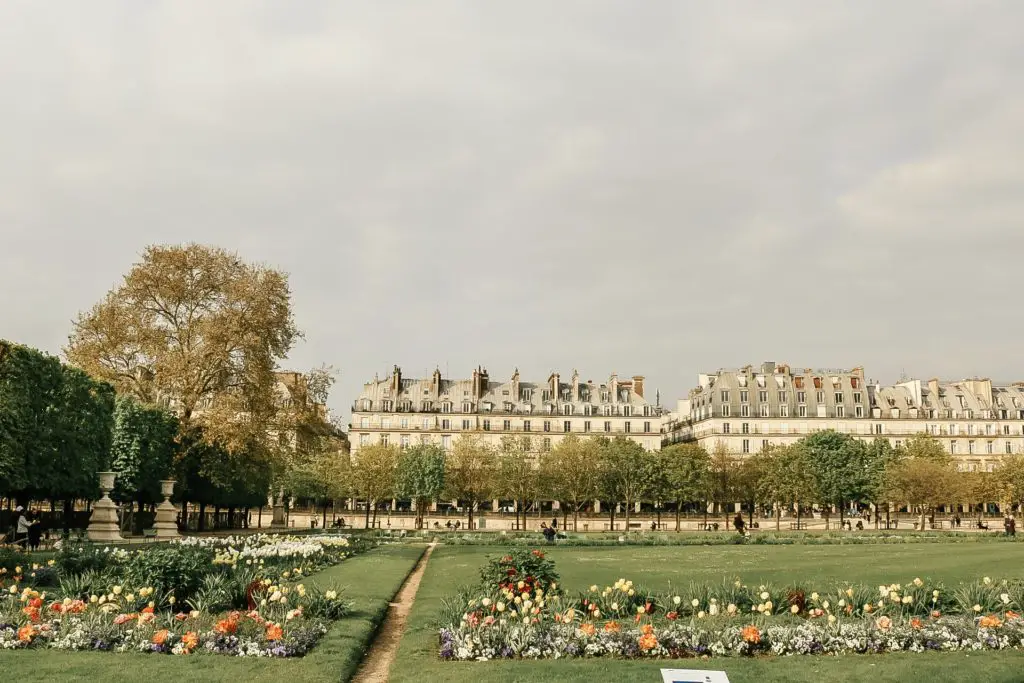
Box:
65;244;299;484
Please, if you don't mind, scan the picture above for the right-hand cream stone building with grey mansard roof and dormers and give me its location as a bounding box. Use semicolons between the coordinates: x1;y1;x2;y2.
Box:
668;362;1024;471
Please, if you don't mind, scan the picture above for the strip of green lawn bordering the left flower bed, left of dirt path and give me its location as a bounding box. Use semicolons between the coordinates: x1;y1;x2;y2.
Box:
0;545;425;683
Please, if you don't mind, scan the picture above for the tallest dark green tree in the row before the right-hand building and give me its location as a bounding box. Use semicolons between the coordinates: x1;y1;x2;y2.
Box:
801;429;871;523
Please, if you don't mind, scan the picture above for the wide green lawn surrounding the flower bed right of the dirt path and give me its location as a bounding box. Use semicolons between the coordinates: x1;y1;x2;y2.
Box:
391;543;1024;683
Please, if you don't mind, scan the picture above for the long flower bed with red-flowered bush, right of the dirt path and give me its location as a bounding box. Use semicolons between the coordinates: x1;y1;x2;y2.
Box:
439;550;1024;659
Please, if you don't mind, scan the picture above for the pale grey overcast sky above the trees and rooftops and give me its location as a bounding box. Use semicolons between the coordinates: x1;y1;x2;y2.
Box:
0;0;1024;413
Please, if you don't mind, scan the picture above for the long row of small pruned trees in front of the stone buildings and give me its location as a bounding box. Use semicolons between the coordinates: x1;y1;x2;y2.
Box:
334;430;1024;530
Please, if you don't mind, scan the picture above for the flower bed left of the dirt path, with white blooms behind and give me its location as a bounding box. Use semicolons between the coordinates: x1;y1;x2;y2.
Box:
0;535;356;656
